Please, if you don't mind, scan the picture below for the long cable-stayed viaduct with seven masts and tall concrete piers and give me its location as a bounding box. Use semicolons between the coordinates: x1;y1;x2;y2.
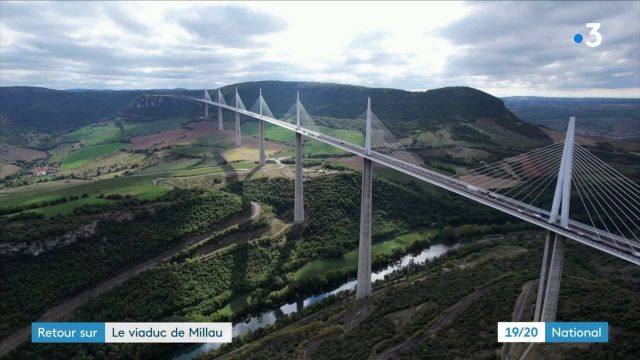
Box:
165;89;640;321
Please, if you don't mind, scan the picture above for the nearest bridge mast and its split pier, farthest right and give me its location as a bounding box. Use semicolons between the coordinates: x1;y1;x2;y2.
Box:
533;116;576;321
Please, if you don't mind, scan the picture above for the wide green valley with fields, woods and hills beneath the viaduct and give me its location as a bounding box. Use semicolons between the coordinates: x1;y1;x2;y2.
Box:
0;81;640;359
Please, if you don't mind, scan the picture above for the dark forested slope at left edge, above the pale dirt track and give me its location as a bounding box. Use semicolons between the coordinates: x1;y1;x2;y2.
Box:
0;190;248;338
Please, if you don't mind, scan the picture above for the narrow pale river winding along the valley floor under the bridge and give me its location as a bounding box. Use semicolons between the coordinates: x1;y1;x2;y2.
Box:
173;243;460;360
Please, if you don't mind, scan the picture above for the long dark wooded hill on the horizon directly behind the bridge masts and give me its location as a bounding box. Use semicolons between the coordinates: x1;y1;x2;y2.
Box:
176;81;548;144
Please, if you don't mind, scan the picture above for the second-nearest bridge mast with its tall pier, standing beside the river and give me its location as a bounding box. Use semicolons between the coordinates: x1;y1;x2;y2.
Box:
356;98;373;299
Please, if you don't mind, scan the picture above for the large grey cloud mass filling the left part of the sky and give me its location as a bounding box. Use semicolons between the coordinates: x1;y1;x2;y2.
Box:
0;2;287;88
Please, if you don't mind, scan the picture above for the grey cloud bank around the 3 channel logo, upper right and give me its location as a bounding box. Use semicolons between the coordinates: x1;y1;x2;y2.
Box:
440;2;640;89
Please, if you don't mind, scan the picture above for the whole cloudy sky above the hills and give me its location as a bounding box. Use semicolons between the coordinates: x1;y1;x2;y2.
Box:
0;1;640;97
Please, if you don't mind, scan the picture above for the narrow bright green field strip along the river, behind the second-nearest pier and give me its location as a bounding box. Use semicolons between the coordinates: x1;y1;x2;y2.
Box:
294;231;431;280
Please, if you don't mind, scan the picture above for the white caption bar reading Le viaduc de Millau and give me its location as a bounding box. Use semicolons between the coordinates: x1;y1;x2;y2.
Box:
105;322;232;343
